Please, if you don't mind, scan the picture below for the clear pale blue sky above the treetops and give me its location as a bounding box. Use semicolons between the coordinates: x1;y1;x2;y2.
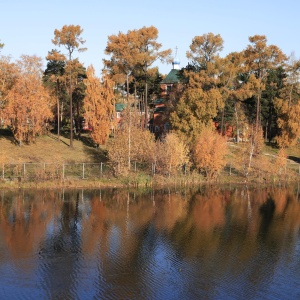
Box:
0;0;300;75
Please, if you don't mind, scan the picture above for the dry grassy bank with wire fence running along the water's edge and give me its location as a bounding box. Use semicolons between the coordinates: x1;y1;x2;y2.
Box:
0;131;300;189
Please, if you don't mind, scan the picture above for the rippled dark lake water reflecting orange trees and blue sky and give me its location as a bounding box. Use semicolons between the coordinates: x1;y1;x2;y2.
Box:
0;186;300;299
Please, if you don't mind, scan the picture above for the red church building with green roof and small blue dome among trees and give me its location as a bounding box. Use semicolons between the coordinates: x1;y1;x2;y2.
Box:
152;53;180;136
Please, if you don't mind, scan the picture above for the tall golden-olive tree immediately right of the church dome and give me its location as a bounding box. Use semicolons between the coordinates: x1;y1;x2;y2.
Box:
170;34;224;142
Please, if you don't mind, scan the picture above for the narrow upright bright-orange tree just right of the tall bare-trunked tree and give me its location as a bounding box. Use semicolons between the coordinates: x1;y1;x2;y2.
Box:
84;66;114;145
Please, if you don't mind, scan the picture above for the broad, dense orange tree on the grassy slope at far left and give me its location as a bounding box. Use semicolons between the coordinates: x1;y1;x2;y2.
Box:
4;55;53;145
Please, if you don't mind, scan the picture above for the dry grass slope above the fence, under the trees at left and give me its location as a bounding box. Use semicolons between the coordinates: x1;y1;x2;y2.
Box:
0;130;105;163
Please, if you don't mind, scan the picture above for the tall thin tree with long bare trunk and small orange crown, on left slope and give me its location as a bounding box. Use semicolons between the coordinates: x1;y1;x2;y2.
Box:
52;25;87;148
